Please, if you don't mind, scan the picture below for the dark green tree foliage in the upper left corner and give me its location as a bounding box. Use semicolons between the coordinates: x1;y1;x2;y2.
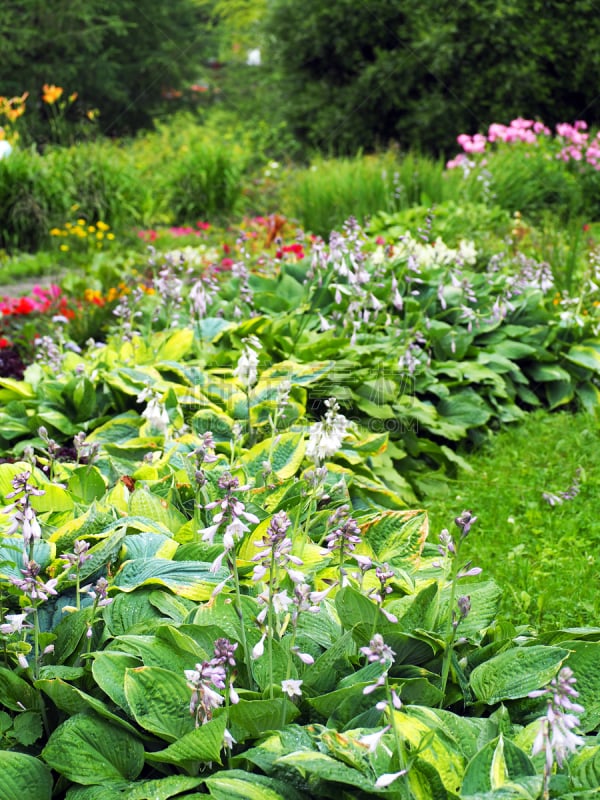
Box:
0;0;216;134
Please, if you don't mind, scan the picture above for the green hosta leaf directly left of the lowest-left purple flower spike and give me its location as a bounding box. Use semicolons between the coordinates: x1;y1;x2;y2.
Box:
124;663;194;742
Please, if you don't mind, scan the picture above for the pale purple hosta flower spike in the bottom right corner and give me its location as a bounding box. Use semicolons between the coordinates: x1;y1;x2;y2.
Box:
529;667;585;797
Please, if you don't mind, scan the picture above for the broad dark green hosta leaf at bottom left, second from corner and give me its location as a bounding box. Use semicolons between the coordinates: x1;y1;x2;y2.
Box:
42;714;144;786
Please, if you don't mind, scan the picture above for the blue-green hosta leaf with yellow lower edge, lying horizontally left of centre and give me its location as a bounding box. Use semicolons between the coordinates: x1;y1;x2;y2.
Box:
114;558;227;601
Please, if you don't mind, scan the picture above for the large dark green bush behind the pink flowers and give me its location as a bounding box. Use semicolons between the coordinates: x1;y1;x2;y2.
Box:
267;0;600;157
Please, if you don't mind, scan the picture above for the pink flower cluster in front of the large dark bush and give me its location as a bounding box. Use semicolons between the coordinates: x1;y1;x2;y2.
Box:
446;117;600;170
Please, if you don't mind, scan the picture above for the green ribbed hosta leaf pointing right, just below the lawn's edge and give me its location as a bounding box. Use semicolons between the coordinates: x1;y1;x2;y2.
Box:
470;645;569;705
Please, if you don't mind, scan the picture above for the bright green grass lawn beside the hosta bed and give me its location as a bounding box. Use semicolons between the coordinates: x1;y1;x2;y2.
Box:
425;412;600;629
